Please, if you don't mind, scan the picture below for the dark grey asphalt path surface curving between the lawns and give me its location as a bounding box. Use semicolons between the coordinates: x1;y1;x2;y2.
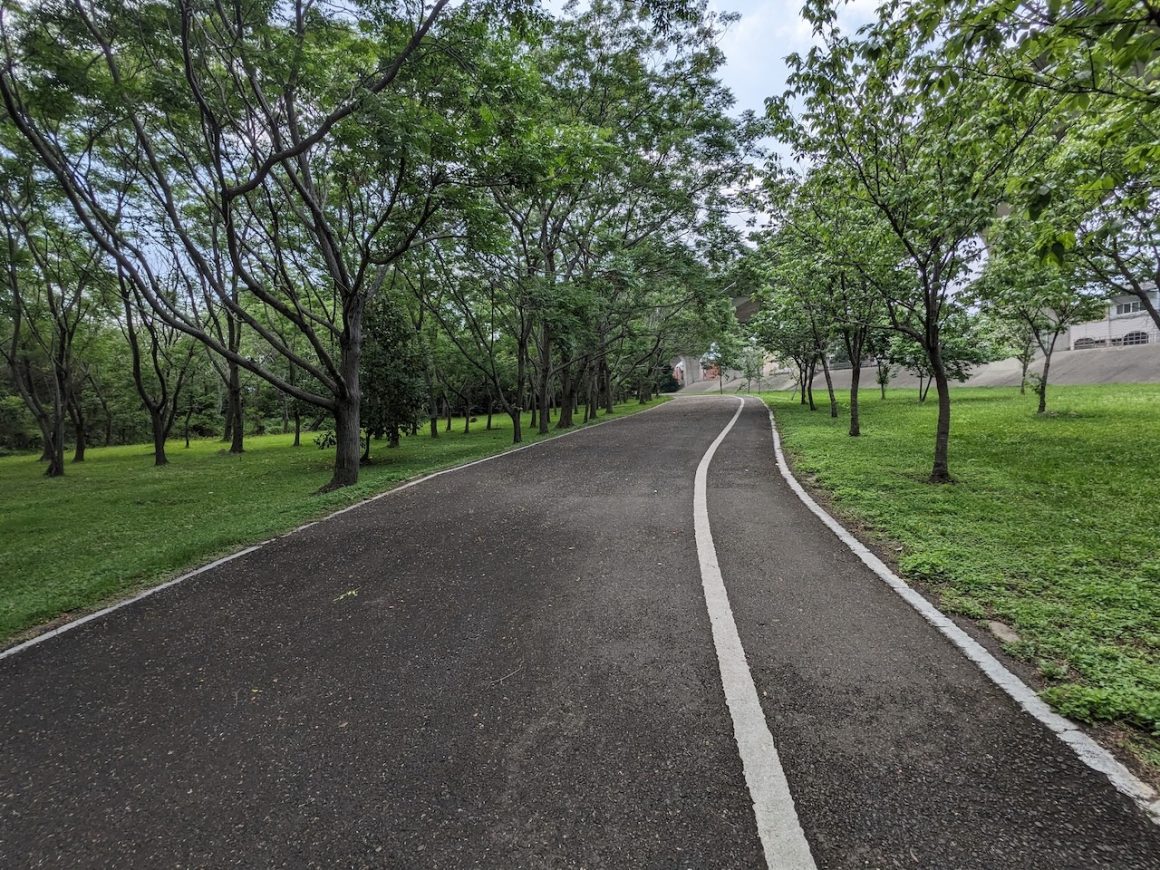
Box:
0;398;1160;868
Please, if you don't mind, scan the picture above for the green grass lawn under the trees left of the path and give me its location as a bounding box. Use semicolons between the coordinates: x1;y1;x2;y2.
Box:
0;403;657;645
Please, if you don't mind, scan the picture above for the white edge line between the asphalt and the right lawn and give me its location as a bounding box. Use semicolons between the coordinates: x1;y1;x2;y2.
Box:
769;411;1160;824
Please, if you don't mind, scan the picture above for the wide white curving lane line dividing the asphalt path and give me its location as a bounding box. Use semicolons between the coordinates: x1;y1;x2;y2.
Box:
693;397;817;870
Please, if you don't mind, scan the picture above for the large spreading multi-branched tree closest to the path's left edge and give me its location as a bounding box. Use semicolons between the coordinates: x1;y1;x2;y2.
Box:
0;0;526;488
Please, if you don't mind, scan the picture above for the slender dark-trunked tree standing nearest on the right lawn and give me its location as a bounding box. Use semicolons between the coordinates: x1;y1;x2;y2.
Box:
769;1;1044;483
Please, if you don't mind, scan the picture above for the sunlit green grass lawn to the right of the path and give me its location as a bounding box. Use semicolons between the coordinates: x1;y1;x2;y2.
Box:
763;384;1160;768
